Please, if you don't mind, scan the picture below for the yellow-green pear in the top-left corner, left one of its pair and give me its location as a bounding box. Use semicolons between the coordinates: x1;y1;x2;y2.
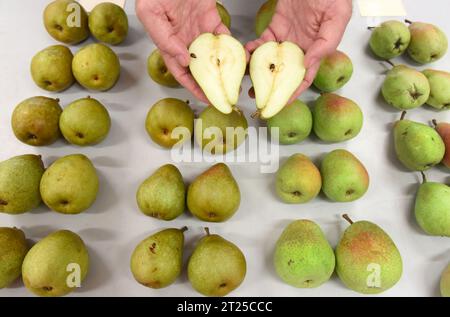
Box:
44;0;89;44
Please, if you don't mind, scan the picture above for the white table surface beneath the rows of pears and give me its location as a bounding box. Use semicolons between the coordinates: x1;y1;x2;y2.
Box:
0;0;450;296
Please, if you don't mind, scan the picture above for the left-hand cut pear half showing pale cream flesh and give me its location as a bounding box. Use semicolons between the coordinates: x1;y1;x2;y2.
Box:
189;33;246;114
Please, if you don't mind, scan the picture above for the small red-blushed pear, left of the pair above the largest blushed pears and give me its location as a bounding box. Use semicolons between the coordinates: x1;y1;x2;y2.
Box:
275;154;322;204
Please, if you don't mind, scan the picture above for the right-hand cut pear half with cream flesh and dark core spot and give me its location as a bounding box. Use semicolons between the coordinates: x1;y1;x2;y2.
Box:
250;41;305;119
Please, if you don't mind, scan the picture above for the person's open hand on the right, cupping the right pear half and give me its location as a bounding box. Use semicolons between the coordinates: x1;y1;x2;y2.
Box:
245;0;352;102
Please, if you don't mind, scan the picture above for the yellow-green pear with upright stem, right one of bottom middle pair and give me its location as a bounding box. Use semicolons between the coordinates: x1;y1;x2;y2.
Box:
188;228;247;297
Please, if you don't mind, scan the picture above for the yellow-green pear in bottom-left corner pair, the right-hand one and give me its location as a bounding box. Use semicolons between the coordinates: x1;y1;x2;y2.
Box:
22;230;89;297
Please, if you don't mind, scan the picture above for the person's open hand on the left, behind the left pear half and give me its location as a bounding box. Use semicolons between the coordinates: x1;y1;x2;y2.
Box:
136;0;230;103
